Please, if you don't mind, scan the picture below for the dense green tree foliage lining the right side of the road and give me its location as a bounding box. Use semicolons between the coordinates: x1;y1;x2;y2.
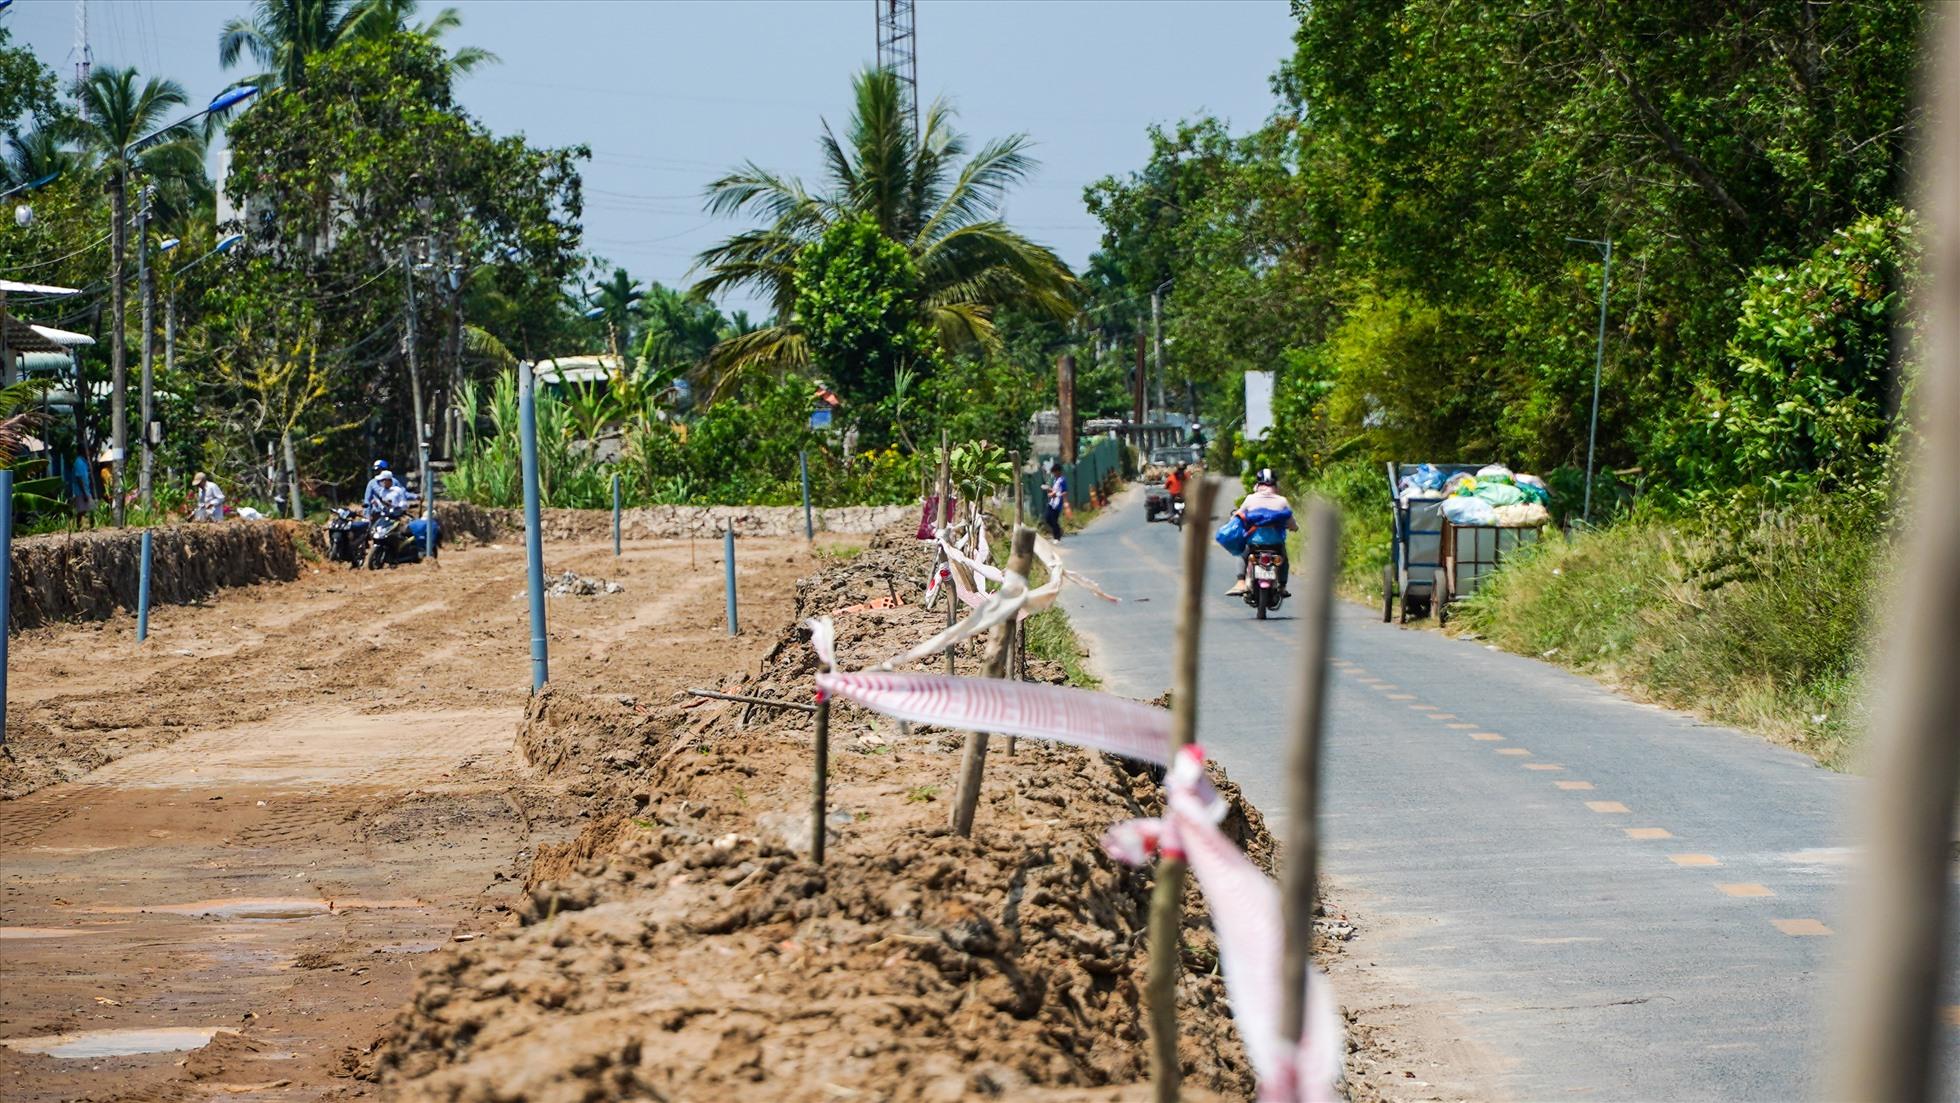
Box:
1088;0;1923;502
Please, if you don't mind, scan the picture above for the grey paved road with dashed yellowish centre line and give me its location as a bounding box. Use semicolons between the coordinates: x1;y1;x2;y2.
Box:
1064;494;1960;1099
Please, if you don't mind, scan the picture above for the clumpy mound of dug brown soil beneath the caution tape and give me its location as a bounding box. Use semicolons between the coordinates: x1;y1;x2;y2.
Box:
376;541;1301;1101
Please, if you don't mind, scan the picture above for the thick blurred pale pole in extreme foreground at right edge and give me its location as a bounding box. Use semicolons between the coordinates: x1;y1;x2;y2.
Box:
1825;12;1960;1099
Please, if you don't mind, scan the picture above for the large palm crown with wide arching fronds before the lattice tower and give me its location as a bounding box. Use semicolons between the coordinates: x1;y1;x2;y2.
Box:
694;71;1076;380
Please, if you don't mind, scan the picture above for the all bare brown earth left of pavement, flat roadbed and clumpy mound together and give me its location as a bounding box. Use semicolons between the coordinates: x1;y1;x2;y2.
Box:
0;521;1454;1101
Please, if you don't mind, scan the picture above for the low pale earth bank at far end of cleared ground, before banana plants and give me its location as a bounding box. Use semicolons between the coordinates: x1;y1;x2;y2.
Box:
435;502;919;543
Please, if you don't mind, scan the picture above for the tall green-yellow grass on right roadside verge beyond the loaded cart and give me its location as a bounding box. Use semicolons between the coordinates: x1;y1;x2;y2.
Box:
1460;500;1887;768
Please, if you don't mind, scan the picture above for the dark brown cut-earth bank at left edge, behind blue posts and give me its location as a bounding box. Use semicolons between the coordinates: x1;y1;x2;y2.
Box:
8;521;319;631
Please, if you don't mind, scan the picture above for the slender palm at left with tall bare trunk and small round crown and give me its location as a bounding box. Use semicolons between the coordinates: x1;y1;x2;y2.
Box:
67;65;202;523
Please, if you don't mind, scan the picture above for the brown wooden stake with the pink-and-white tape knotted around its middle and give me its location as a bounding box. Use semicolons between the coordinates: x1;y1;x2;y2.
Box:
1143;478;1219;1103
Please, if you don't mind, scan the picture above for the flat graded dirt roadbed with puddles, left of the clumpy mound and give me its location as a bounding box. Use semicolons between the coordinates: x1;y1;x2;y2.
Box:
0;539;813;1101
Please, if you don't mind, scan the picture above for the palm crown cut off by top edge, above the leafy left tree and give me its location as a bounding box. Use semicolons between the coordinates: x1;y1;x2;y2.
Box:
218;0;498;88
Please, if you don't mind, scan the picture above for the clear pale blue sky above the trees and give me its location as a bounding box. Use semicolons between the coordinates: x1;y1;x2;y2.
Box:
15;0;1292;308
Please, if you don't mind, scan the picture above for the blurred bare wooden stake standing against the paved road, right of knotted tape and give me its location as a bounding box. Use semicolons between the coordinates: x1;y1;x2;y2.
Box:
1280;498;1341;1046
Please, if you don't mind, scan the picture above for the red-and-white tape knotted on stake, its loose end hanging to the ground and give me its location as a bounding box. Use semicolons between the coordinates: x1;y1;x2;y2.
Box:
1103;746;1347;1103
